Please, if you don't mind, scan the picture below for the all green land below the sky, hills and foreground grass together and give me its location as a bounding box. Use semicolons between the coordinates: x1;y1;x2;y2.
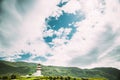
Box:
0;61;120;80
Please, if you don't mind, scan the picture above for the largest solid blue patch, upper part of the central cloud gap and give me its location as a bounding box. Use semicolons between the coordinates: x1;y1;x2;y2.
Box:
45;11;85;31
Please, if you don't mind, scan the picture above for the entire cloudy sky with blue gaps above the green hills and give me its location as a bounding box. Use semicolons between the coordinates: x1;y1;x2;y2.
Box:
0;0;120;69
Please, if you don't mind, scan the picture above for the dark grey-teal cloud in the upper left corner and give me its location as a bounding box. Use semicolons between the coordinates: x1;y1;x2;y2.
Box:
0;0;35;48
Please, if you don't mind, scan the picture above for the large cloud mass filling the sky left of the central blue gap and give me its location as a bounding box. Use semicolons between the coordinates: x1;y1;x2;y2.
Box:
0;0;58;62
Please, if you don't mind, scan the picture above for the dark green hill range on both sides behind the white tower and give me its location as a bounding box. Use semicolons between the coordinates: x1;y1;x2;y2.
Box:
0;61;120;80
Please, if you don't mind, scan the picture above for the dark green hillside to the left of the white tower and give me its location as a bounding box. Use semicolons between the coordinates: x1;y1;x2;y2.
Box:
0;61;36;75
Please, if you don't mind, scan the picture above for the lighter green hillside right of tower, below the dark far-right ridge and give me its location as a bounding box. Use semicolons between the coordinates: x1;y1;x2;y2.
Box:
42;66;116;80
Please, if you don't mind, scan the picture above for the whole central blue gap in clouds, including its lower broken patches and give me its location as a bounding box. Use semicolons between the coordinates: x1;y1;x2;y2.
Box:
43;11;85;47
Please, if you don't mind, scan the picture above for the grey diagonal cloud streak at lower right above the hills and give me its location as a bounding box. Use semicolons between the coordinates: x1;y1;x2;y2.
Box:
70;26;119;66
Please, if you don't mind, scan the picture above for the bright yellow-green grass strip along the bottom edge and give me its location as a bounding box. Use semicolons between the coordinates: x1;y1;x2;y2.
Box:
0;76;108;80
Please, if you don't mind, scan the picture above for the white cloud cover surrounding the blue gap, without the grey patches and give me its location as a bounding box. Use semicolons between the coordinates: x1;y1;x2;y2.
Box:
0;0;120;69
